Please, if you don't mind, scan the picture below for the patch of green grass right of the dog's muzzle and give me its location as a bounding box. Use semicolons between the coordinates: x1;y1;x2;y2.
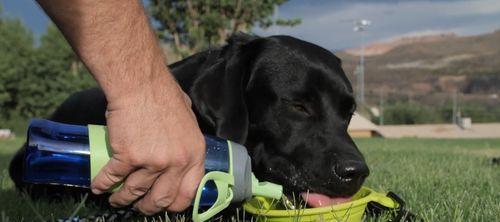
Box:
357;139;500;221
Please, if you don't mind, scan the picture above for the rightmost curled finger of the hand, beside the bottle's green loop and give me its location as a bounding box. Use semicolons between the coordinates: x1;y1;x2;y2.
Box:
167;162;205;212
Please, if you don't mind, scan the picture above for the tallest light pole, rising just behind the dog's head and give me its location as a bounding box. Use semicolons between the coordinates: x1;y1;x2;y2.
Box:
354;19;372;104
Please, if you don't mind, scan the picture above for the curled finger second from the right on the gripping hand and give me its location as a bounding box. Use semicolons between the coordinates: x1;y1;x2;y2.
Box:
134;168;182;215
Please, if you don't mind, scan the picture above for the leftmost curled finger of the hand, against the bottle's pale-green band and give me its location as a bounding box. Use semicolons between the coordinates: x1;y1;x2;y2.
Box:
91;157;134;194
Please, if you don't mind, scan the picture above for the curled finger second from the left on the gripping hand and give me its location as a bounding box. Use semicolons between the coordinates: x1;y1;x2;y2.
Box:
109;168;160;207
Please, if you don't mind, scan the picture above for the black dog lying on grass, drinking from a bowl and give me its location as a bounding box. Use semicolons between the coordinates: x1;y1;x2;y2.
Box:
6;34;369;206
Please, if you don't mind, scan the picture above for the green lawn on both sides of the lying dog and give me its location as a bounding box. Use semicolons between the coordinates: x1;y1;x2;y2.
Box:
0;138;500;221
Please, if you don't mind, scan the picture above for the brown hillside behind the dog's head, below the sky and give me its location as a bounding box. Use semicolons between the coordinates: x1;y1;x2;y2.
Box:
335;30;500;109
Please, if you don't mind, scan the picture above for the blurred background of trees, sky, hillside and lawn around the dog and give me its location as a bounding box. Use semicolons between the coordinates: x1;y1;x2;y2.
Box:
0;0;500;222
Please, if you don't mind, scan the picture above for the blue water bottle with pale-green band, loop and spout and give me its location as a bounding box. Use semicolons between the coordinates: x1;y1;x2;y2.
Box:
23;119;282;221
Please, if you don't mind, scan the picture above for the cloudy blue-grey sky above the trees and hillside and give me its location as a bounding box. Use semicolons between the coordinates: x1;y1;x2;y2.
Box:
0;0;500;50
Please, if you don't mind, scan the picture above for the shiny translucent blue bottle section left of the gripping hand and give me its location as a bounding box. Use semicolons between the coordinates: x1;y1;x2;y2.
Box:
23;119;91;187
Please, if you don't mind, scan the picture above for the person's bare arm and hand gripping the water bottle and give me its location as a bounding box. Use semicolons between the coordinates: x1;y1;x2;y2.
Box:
38;0;205;214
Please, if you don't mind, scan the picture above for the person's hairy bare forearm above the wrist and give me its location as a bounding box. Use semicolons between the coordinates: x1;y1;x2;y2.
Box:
38;0;176;101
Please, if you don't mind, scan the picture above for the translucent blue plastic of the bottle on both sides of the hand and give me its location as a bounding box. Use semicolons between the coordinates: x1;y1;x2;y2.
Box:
24;119;230;206
